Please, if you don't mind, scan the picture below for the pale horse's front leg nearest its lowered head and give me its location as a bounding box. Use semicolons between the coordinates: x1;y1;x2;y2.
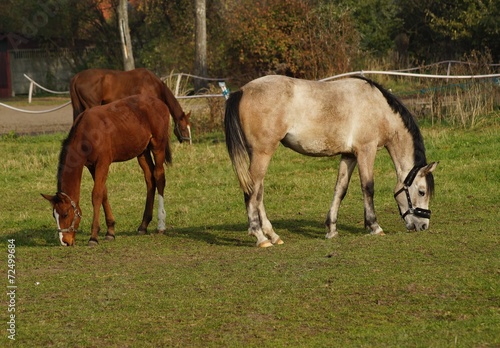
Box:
358;151;384;235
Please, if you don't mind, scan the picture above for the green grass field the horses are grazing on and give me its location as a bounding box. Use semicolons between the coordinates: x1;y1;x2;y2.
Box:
0;113;500;347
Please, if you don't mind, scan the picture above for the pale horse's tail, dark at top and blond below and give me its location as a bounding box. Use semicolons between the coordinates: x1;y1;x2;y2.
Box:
224;91;253;194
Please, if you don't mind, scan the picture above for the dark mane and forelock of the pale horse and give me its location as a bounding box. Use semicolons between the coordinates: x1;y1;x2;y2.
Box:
353;76;434;195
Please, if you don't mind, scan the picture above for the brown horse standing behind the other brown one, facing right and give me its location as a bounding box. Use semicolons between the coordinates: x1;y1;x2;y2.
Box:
70;68;191;143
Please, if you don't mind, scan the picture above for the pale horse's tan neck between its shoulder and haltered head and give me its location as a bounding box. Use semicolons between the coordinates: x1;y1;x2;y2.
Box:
386;129;422;183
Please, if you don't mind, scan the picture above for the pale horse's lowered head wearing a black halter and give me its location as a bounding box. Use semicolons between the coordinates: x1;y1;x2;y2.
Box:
394;162;438;231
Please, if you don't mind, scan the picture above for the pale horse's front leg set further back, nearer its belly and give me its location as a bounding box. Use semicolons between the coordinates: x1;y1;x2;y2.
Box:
325;155;356;239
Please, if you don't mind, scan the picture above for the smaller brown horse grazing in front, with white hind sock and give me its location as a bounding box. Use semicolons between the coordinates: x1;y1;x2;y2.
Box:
42;95;172;245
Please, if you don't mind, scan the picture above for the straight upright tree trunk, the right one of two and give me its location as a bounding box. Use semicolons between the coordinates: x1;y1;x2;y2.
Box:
194;0;208;92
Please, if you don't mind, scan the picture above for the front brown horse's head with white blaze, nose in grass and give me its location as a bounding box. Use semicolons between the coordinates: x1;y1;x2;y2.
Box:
42;192;82;246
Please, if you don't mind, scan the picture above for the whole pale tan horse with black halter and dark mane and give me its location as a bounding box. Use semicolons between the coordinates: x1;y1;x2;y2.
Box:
224;75;437;247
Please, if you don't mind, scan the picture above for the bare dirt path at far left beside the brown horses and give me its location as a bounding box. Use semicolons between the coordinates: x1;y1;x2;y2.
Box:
0;105;73;134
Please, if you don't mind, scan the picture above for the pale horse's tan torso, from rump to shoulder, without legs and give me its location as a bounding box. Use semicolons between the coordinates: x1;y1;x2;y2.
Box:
240;75;402;156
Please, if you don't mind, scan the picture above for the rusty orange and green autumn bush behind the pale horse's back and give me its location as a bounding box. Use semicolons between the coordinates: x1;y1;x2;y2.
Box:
228;0;359;79
